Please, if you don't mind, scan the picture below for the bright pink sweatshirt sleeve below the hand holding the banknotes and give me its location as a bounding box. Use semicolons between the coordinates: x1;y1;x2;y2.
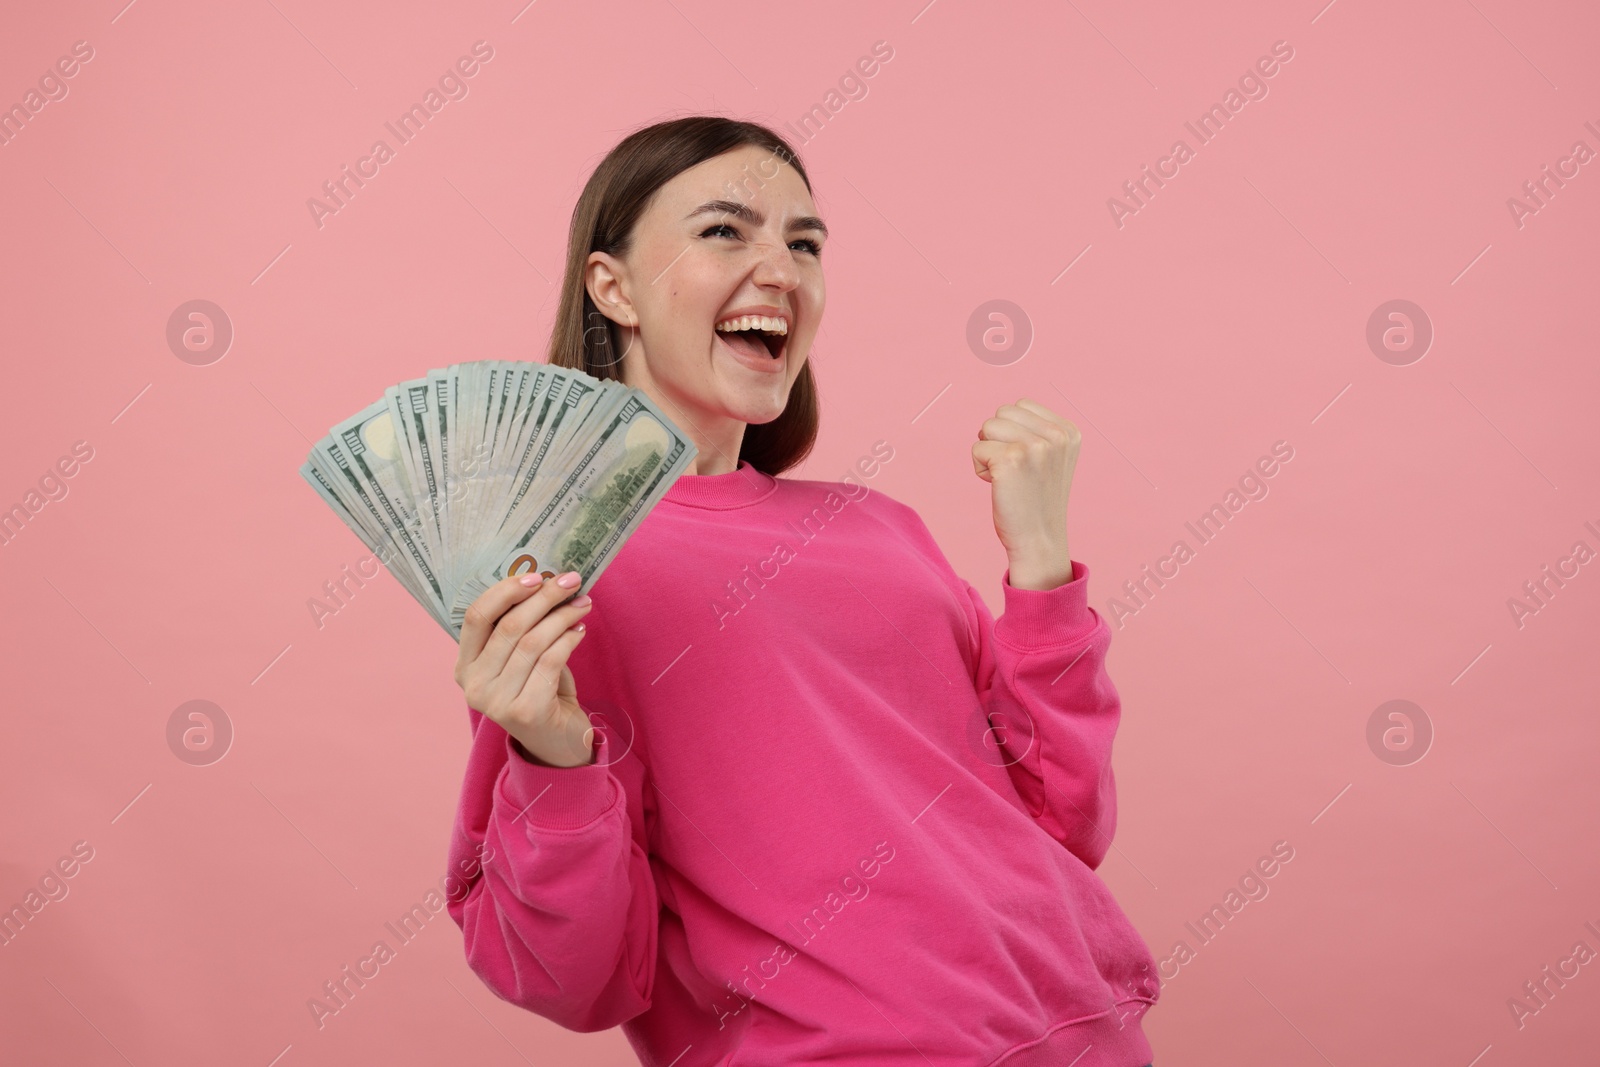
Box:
448;709;659;1032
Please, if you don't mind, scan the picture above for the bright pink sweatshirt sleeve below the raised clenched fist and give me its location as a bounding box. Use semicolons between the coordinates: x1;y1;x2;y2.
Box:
962;560;1122;869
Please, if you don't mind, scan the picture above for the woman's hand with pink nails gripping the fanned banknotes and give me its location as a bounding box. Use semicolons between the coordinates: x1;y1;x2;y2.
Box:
456;571;595;766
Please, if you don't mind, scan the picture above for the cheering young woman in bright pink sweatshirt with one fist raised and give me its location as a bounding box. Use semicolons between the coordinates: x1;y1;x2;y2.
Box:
450;117;1158;1067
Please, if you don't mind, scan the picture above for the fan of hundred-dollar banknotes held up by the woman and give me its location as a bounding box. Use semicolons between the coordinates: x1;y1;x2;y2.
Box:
301;360;696;638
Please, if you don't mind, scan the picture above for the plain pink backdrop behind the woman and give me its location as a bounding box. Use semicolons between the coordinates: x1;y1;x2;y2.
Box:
0;0;1600;1067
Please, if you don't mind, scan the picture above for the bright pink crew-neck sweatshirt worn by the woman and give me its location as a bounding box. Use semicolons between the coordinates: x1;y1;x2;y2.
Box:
450;453;1160;1067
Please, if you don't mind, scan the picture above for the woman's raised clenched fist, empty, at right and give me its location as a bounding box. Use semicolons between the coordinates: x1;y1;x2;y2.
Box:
973;397;1083;589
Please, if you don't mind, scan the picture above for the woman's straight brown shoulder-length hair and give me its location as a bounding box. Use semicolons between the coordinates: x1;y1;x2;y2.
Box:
549;115;819;475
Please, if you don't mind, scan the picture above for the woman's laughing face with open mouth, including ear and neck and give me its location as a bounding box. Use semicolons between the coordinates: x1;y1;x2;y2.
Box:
586;146;827;472
